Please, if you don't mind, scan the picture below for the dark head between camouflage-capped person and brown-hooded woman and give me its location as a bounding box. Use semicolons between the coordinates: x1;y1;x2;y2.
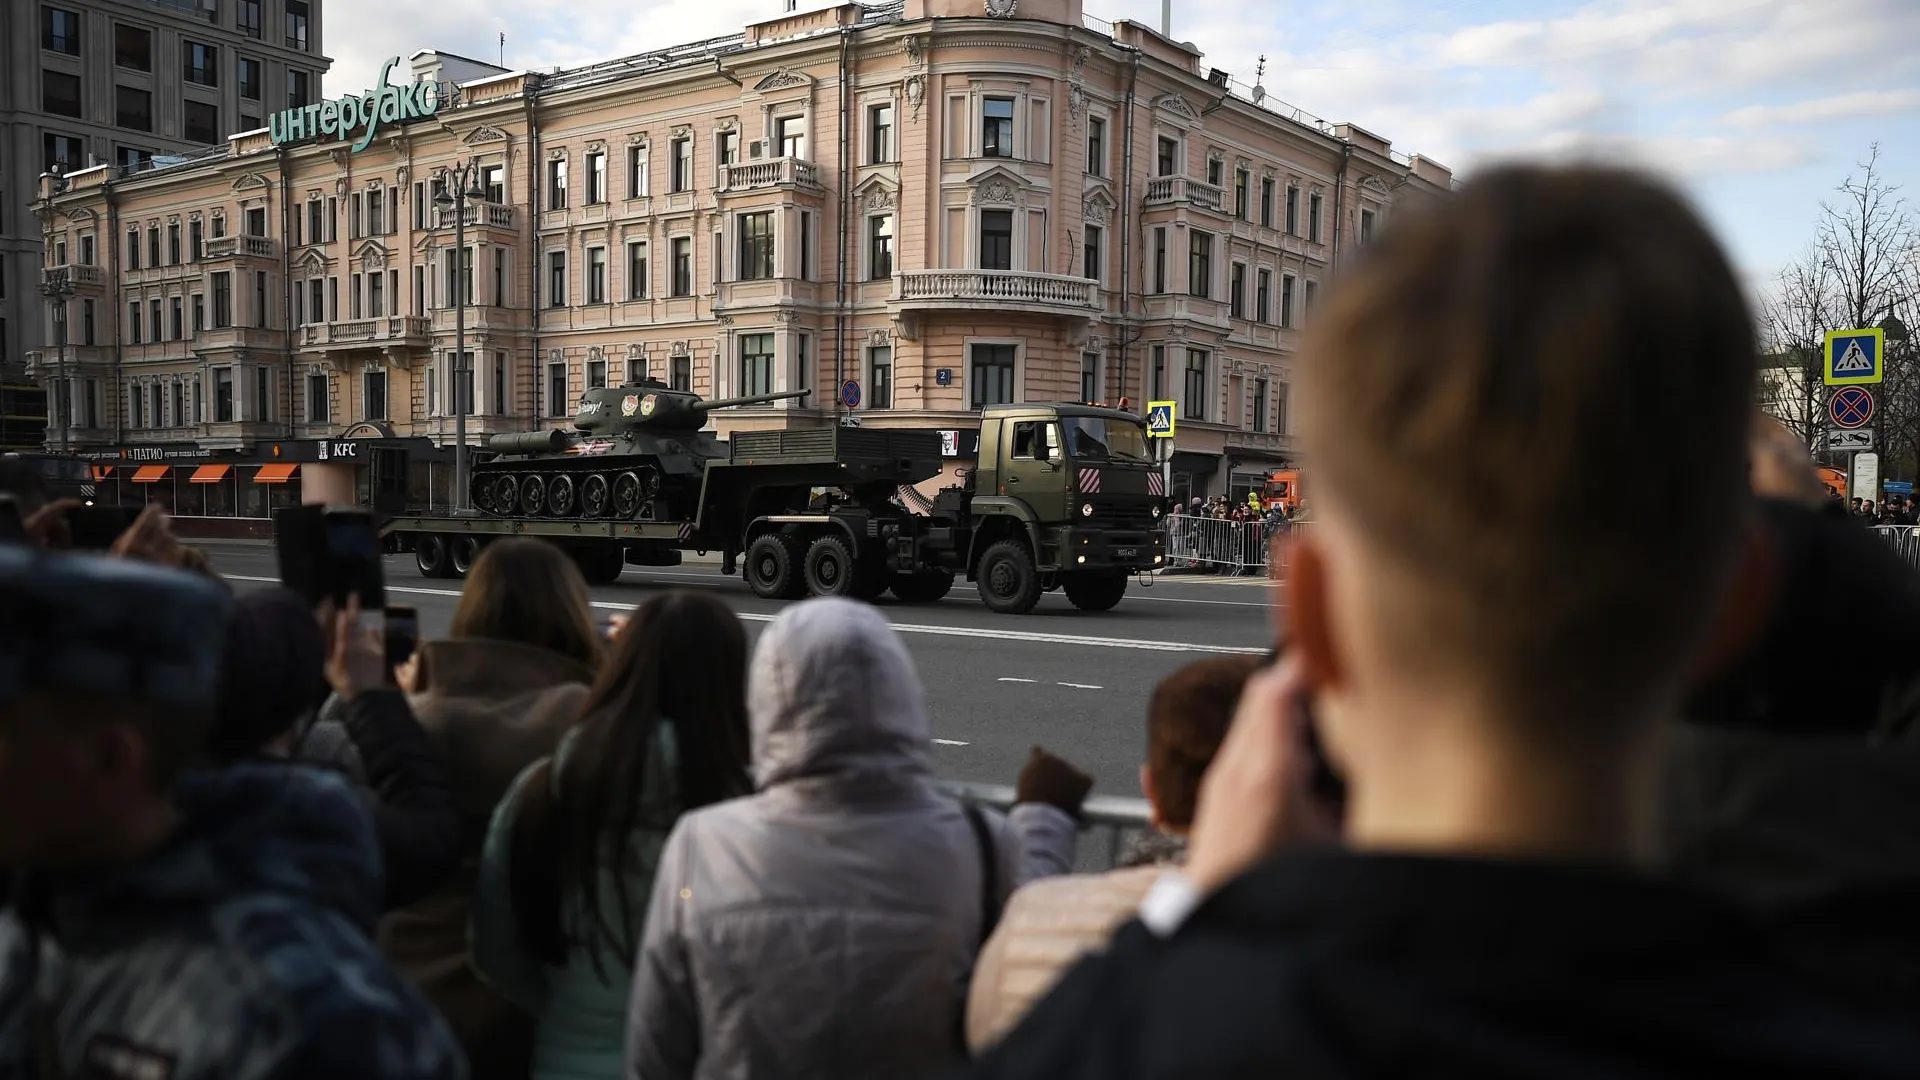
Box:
205;588;326;761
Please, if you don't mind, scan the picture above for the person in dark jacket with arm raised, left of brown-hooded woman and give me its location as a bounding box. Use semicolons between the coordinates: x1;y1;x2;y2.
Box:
207;588;461;909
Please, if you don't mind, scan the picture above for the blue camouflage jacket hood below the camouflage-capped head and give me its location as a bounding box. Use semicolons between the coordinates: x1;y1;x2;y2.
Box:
48;763;382;940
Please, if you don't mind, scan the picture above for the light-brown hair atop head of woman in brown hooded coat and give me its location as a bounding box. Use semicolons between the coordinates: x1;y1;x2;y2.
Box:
449;536;601;667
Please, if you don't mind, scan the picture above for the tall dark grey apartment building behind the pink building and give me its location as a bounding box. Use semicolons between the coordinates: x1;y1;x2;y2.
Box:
0;0;328;390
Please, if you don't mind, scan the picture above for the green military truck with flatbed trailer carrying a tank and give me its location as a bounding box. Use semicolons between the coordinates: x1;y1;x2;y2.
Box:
388;388;1165;613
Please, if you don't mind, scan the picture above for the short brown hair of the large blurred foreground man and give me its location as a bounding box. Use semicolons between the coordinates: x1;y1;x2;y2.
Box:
1300;167;1755;719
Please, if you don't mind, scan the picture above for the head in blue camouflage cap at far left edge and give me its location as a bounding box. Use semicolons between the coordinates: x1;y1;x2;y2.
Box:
0;544;232;871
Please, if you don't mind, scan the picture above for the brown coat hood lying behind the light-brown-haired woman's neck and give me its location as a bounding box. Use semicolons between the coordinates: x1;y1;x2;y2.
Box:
407;638;593;815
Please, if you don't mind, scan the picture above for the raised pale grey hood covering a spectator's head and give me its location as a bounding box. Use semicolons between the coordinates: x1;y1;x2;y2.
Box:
747;598;933;788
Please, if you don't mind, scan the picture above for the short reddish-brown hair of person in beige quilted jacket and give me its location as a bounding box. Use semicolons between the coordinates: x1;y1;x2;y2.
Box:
1146;655;1265;828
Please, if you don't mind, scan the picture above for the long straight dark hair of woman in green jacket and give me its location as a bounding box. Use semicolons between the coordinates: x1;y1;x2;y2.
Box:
515;592;753;963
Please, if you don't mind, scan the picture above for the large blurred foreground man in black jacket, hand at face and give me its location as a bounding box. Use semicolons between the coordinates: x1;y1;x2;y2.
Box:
975;165;1920;1080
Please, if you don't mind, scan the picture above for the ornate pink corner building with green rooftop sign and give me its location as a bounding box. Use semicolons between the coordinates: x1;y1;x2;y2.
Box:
33;0;1452;502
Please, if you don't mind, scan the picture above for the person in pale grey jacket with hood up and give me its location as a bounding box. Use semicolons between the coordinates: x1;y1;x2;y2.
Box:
626;600;1085;1080
